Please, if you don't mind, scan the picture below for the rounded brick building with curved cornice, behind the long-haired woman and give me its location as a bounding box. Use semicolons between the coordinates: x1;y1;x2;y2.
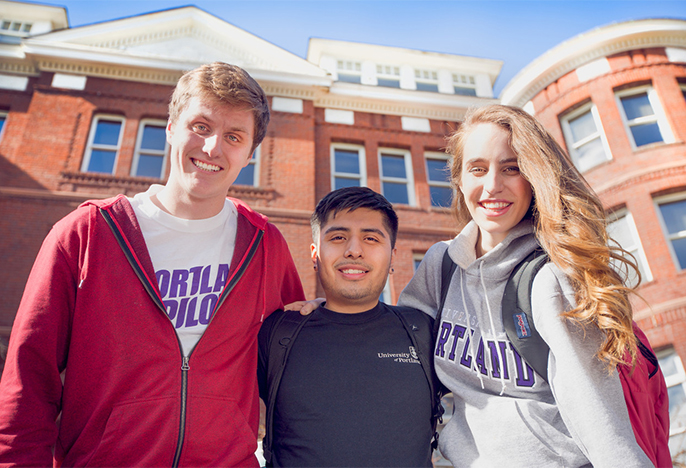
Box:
501;19;686;454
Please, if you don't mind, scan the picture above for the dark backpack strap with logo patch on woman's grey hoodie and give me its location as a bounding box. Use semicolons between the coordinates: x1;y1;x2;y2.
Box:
502;248;550;382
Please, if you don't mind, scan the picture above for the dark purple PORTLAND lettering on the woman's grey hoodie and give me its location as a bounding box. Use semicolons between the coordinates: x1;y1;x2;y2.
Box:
434;321;535;388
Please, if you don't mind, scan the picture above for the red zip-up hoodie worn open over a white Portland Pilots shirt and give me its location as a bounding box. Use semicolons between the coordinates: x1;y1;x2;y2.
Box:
0;195;304;467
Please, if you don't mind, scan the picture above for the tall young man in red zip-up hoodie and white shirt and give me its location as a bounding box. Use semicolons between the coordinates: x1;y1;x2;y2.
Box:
0;62;303;467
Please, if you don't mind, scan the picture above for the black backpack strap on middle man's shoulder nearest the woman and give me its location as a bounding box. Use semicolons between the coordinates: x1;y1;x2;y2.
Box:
390;307;445;450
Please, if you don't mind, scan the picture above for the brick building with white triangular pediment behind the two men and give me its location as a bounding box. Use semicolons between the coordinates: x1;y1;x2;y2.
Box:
0;0;502;350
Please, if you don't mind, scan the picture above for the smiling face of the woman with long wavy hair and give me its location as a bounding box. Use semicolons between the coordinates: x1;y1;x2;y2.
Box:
459;123;532;256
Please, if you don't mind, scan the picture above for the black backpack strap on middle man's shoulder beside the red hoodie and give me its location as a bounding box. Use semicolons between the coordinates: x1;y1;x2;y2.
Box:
262;311;314;466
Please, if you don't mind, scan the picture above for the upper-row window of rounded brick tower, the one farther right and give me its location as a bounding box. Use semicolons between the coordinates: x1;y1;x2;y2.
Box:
617;86;673;148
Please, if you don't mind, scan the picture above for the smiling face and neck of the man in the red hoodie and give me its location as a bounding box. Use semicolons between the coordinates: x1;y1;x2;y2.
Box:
157;97;255;219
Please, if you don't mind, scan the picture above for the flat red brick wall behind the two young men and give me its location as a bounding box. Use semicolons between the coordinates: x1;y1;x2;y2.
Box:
0;69;464;331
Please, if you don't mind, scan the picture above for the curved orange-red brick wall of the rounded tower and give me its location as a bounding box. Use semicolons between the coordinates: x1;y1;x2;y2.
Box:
532;48;686;359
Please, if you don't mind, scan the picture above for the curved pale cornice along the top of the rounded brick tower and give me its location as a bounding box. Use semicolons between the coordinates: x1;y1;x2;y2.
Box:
500;19;686;107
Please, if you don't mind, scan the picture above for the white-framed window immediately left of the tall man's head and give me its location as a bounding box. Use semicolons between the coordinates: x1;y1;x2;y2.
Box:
131;120;167;179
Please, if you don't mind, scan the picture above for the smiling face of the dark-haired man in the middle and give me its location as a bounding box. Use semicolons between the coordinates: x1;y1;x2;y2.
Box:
311;208;395;314
